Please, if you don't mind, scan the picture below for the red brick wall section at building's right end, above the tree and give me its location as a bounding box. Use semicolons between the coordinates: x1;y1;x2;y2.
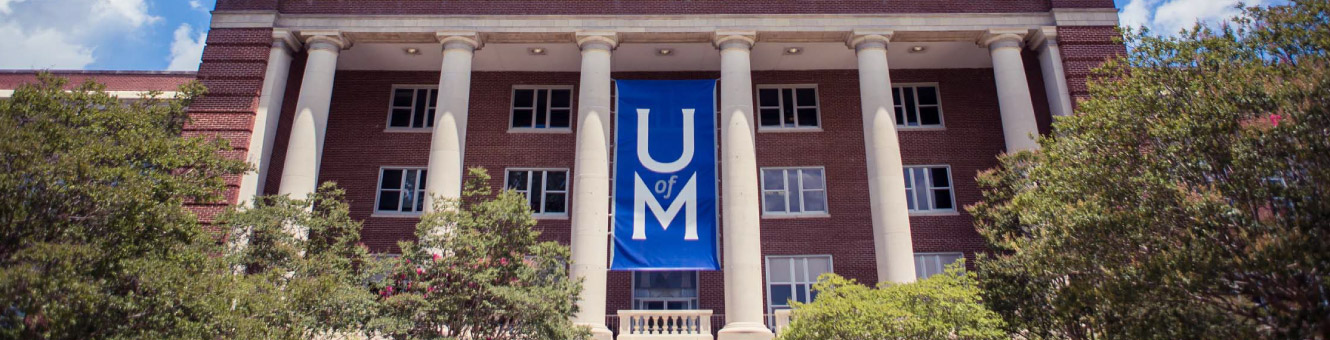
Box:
1057;27;1127;108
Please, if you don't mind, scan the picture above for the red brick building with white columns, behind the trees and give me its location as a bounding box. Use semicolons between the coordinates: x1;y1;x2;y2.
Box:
0;0;1124;339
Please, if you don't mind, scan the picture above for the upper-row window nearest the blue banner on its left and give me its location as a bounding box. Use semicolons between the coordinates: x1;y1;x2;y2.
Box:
512;86;573;129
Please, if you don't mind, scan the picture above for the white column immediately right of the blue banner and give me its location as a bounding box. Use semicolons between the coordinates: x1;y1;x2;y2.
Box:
716;32;773;340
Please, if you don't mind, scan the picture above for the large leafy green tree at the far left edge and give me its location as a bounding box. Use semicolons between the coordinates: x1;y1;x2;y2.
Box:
0;74;245;339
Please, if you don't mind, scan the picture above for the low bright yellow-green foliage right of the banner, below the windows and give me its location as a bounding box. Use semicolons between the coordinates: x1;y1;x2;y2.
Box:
781;263;1007;340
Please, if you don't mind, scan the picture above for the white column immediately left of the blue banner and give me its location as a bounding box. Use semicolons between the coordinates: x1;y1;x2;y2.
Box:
571;33;618;340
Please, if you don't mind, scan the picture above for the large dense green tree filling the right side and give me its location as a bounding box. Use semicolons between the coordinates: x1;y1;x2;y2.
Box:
970;0;1330;339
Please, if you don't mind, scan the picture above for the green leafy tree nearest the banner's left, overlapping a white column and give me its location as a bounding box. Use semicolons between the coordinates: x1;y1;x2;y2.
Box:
370;169;589;340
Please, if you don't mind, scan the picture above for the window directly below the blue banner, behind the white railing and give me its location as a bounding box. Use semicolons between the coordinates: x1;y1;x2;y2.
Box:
633;271;697;311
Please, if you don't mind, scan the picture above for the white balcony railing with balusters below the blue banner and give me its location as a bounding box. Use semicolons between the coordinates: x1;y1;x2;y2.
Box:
616;309;712;340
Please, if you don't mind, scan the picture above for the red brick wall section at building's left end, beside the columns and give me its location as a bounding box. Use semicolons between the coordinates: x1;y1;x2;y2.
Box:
185;28;273;227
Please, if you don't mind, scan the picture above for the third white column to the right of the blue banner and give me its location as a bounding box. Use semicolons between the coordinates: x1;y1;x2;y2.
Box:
980;29;1039;153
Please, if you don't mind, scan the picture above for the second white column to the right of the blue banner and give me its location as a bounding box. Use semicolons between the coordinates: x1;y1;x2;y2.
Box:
850;32;915;283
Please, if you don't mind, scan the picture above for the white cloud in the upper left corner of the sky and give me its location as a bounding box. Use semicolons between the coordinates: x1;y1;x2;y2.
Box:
0;0;162;69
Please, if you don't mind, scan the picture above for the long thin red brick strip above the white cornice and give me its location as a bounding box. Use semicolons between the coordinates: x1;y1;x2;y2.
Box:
217;0;1113;15
